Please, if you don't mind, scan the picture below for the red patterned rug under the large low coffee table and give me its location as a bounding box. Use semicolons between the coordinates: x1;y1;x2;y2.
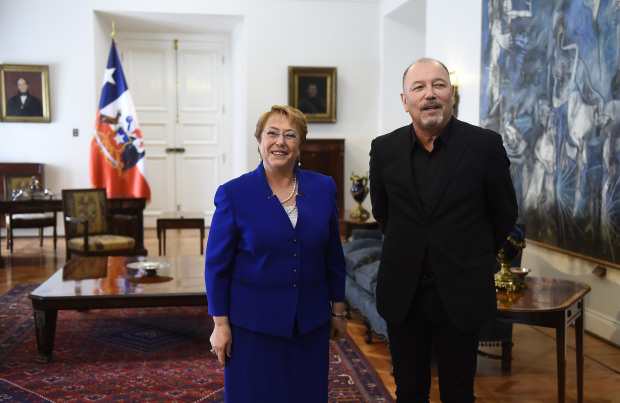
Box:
0;284;393;403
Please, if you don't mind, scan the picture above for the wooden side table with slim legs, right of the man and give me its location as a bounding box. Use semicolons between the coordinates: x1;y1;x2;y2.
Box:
497;277;590;403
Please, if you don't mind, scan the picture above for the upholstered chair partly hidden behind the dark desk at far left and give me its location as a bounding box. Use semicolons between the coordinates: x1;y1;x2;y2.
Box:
4;173;56;253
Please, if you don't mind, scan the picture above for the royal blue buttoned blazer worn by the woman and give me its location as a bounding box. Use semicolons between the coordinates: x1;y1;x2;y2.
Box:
205;163;346;337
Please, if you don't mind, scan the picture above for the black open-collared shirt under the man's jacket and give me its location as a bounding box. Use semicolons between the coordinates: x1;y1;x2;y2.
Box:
411;120;452;277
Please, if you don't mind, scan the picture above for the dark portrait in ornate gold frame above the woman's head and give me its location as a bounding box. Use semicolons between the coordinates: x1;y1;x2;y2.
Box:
288;66;337;123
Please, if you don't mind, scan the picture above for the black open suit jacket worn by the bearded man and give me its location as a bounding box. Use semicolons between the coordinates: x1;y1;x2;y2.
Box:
370;118;518;330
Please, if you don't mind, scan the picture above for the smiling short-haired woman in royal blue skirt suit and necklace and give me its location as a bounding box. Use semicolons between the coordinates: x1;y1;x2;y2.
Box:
205;105;346;403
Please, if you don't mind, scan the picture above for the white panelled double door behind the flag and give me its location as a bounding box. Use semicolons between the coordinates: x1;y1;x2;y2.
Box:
118;36;231;227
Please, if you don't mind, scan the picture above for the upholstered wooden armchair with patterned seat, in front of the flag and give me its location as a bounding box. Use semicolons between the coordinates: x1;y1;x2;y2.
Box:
62;188;137;260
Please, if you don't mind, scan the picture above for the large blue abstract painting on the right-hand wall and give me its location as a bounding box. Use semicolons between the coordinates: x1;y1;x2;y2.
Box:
480;0;620;264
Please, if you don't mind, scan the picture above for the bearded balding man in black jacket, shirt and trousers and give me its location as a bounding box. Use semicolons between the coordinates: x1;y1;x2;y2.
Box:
370;58;517;403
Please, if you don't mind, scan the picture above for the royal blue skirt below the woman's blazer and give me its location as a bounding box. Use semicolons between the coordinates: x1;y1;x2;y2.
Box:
224;321;330;403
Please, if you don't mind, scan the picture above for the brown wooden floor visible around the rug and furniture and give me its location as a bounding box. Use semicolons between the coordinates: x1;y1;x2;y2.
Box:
0;229;620;403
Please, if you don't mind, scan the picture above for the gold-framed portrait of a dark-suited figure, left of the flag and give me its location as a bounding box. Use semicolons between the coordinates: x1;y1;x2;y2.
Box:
0;64;51;123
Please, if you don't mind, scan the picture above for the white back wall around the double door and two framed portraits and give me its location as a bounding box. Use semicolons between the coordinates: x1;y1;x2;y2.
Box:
0;0;379;215
